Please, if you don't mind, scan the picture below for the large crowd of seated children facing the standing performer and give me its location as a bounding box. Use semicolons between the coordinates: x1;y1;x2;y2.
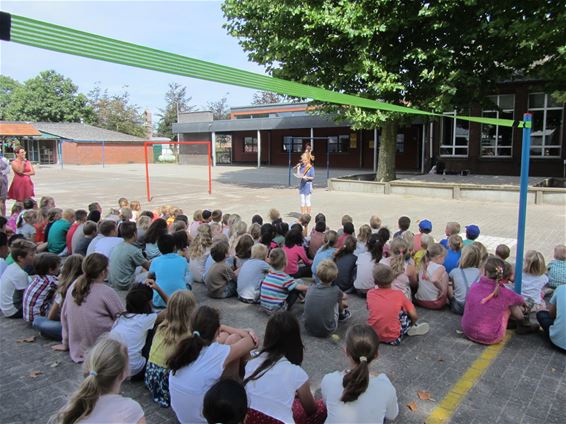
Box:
0;198;566;423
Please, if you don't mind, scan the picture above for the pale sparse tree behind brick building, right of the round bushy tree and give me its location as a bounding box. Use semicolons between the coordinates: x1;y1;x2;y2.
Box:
88;84;146;137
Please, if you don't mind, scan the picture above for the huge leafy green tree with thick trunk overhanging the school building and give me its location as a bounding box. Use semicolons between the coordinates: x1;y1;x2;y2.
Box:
222;0;566;181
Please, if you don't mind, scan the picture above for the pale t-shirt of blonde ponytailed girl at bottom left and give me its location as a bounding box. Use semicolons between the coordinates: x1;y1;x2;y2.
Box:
80;394;144;424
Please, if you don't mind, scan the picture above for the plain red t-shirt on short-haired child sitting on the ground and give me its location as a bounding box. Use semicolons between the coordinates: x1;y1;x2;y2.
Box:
367;288;415;343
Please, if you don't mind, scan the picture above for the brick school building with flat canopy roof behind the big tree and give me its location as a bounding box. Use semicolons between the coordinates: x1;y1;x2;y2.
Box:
173;81;566;177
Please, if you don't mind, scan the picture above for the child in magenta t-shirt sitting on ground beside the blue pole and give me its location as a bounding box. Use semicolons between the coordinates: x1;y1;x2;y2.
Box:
462;256;538;345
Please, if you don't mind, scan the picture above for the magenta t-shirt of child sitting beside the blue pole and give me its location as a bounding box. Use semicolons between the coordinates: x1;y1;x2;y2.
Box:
462;277;524;344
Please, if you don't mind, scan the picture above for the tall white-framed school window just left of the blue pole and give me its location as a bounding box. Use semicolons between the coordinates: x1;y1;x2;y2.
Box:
480;94;515;157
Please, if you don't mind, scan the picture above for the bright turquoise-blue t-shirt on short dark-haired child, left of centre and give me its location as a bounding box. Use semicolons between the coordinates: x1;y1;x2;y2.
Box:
149;253;190;308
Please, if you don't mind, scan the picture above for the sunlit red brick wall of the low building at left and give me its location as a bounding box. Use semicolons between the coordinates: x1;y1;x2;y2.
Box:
63;142;153;165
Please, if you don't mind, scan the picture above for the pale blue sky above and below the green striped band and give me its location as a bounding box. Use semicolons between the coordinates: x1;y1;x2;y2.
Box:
0;0;270;122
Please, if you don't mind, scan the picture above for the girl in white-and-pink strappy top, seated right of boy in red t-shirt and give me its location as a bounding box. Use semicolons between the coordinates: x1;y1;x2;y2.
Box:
415;243;448;309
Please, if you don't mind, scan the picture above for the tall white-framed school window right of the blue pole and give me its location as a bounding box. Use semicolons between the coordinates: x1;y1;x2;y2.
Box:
529;93;563;158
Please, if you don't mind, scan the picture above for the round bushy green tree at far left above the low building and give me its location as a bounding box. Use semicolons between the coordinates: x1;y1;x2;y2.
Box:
2;70;94;122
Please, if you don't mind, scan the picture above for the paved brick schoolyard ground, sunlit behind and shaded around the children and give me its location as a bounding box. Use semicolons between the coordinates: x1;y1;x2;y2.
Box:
0;165;566;423
